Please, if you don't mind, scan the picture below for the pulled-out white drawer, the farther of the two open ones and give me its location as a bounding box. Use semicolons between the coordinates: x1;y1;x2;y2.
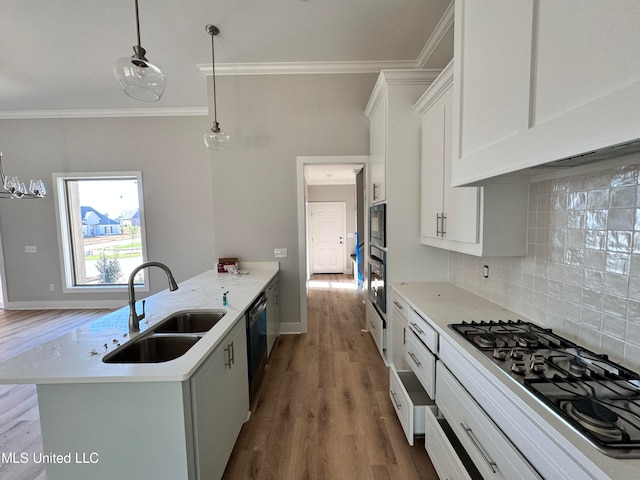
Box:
389;368;434;446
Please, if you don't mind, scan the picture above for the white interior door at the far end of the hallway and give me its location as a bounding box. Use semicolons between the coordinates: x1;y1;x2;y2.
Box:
308;202;346;273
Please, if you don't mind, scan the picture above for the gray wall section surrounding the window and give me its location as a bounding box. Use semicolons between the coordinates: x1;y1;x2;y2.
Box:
0;117;214;307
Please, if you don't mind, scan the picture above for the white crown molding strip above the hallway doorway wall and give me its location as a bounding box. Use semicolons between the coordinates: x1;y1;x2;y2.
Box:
197;60;416;75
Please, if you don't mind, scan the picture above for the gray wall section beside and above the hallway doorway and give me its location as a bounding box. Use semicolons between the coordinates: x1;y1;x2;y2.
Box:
212;74;377;331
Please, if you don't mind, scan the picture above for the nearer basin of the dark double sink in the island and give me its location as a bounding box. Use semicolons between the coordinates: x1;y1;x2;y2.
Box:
102;335;202;363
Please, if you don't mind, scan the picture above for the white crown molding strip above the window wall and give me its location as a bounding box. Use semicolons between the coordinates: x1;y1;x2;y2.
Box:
0;107;209;120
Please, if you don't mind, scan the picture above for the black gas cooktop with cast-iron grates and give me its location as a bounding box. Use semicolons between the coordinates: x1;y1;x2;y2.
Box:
449;320;640;458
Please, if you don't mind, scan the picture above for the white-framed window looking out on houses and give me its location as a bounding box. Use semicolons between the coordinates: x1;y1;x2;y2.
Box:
53;172;148;292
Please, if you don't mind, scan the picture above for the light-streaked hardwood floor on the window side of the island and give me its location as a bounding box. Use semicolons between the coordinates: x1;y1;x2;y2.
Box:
0;310;110;480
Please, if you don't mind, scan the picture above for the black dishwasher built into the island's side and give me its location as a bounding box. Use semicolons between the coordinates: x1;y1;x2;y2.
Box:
246;293;267;398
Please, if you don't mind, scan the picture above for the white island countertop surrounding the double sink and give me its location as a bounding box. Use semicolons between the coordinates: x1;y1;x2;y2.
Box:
0;262;278;384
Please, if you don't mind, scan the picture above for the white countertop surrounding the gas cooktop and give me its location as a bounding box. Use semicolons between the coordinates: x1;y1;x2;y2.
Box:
393;282;640;479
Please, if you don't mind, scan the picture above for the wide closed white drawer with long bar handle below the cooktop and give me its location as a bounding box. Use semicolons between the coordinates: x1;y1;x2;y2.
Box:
436;362;541;480
